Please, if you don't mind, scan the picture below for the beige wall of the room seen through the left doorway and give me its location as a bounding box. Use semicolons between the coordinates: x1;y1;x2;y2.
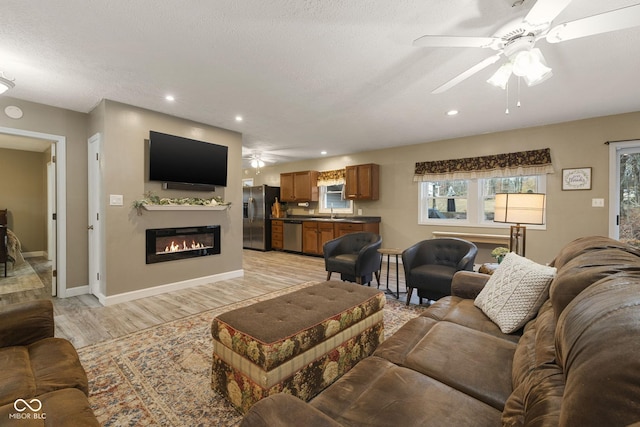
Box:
0;148;47;252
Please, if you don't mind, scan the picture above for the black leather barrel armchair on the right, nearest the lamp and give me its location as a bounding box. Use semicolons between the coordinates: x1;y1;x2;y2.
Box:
402;238;478;305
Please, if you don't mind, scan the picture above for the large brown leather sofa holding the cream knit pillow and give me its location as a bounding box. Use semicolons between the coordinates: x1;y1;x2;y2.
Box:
242;237;640;427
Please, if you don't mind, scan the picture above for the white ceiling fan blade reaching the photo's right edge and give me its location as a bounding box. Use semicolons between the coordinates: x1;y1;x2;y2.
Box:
546;4;640;43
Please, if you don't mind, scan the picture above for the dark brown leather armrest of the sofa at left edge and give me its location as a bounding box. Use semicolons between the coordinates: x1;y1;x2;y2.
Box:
0;300;55;347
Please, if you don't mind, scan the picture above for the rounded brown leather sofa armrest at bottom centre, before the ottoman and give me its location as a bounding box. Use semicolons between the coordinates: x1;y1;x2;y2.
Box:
240;393;342;427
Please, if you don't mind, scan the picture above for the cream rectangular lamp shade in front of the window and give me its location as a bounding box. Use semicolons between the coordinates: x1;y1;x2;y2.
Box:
493;193;545;224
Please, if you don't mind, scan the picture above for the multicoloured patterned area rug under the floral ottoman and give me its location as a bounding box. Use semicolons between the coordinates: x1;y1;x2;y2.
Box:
78;282;425;427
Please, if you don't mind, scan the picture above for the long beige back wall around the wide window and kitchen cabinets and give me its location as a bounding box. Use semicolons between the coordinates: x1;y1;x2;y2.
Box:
249;113;640;262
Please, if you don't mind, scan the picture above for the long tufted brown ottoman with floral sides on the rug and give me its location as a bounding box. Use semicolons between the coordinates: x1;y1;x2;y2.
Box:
211;281;385;413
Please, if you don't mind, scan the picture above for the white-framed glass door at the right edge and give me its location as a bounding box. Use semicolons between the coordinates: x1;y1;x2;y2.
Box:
609;140;640;242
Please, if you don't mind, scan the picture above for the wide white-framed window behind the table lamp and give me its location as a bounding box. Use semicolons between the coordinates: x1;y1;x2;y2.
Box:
418;175;546;228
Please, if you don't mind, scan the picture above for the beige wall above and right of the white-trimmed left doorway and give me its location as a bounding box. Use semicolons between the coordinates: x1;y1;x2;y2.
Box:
0;96;88;289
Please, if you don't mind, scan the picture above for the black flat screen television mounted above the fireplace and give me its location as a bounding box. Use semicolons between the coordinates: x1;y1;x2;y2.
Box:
149;131;228;187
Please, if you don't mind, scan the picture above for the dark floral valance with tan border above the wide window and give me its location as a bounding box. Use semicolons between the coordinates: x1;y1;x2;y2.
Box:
413;148;554;181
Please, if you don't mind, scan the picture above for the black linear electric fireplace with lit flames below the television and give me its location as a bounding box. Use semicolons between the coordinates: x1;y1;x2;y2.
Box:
146;225;220;264
